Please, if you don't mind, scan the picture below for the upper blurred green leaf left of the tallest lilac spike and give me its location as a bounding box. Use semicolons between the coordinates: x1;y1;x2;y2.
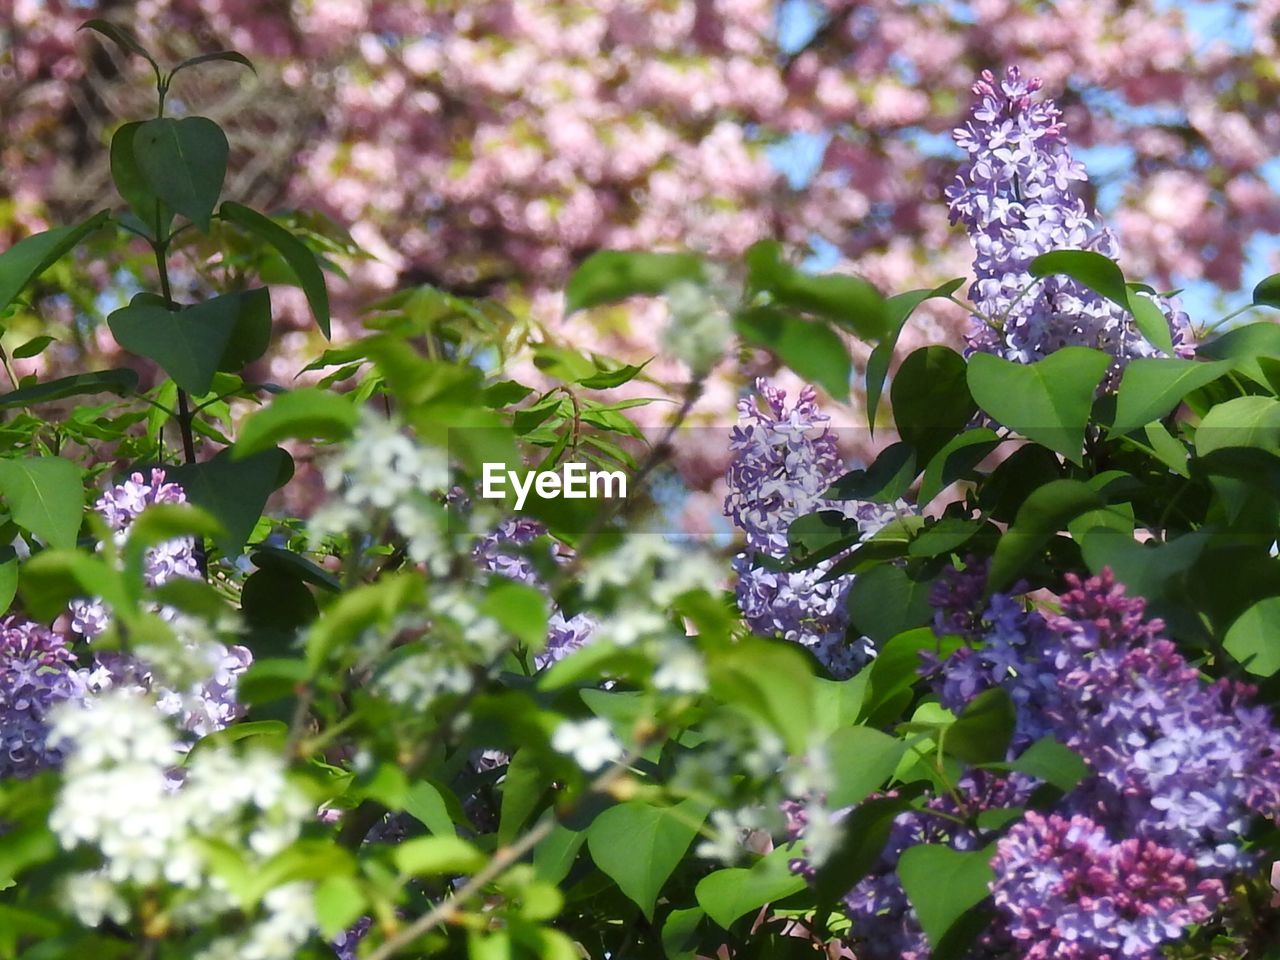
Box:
746;241;888;343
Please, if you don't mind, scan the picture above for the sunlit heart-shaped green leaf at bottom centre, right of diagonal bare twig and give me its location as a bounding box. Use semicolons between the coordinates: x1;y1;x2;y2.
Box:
586;800;708;922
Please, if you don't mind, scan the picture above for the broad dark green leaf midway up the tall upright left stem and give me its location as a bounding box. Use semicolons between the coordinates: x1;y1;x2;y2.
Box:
106;293;241;397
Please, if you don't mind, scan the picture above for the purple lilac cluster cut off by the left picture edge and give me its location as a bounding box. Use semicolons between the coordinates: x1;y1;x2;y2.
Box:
0;617;86;780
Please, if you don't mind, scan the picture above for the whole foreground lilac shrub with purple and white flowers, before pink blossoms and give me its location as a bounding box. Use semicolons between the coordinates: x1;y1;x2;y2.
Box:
0;20;1280;960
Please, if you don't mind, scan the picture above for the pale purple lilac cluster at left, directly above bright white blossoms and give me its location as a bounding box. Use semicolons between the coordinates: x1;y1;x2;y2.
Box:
70;468;253;736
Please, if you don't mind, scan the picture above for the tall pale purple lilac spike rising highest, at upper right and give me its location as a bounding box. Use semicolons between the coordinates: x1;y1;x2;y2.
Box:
946;67;1190;364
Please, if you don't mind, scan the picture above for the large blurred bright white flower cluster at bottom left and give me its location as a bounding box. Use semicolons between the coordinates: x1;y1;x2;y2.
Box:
49;690;315;960
